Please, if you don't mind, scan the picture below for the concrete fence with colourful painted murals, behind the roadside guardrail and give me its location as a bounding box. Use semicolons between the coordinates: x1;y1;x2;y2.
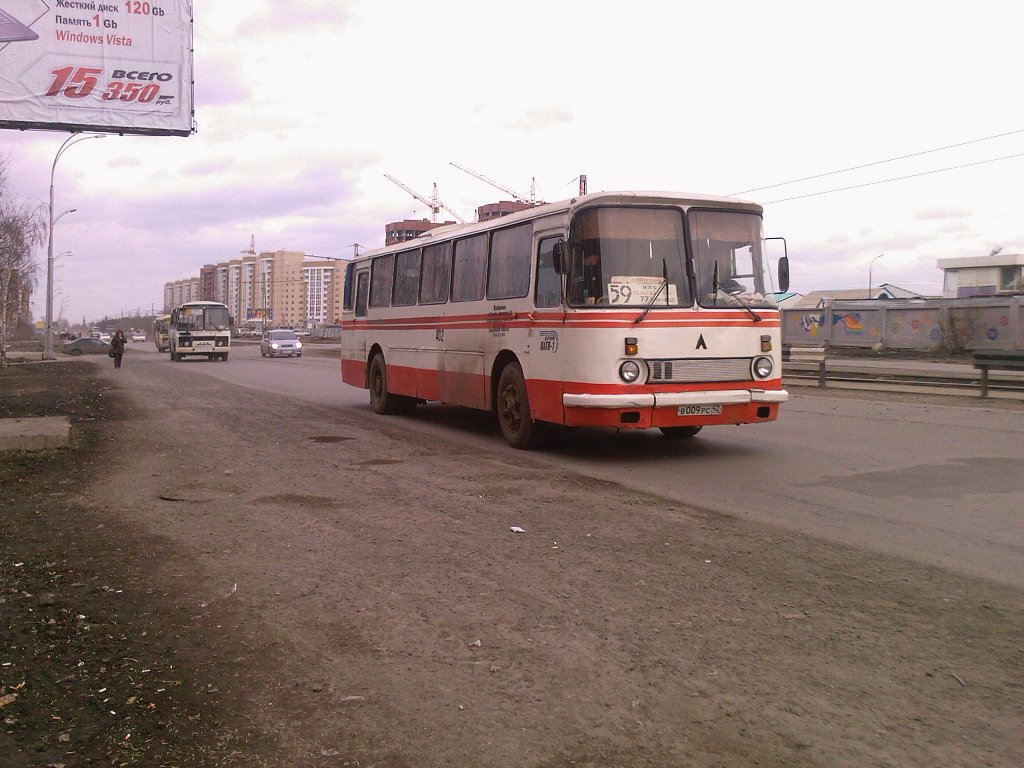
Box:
782;296;1024;352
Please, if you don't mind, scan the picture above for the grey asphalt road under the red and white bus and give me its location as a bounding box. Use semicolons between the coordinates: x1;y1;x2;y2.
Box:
138;344;1024;589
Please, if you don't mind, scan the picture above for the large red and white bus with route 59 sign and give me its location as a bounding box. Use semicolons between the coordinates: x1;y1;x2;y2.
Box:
341;191;788;449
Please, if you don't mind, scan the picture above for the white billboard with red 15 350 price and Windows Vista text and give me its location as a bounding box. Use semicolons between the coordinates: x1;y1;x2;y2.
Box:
0;0;194;136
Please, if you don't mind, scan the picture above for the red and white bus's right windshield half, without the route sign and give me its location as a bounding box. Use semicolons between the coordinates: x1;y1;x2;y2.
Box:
689;211;776;307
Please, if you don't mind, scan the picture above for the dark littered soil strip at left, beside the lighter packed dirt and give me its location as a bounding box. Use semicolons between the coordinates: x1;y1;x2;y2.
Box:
0;361;280;767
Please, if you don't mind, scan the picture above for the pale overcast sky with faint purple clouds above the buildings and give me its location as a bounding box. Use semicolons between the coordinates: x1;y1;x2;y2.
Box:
0;0;1024;322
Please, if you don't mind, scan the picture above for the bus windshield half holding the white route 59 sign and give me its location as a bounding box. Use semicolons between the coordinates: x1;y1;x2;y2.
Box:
568;207;692;307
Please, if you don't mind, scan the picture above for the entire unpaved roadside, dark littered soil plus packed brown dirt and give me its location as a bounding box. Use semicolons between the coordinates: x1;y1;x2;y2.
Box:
0;356;1024;768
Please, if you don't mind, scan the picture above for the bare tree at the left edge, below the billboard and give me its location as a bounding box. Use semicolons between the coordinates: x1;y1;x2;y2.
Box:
0;158;46;368
